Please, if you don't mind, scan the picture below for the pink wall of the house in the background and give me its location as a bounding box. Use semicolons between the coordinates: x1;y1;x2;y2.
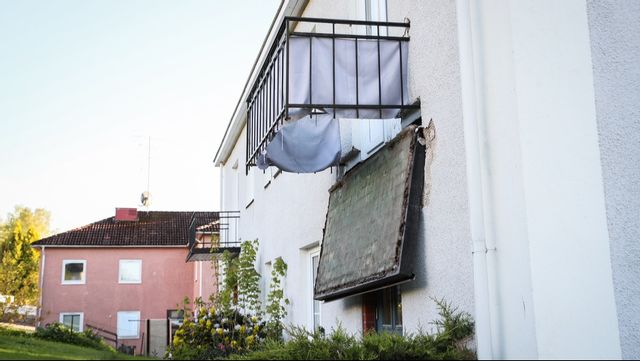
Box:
41;248;201;351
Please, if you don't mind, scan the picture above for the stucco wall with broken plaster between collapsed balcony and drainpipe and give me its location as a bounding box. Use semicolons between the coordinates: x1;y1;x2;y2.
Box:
388;0;474;331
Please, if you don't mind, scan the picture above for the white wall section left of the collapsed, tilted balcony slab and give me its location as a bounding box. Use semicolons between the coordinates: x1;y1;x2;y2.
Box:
221;128;335;329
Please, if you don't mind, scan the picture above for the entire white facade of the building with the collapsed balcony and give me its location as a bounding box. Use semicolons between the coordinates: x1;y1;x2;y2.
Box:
215;0;640;359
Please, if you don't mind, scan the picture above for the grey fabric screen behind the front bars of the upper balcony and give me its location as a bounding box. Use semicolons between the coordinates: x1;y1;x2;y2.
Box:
284;36;409;119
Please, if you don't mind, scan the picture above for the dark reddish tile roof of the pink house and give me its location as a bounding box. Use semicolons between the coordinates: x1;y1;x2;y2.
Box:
33;211;219;247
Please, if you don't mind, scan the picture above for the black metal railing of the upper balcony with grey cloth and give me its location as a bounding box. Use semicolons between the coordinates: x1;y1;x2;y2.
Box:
246;17;419;167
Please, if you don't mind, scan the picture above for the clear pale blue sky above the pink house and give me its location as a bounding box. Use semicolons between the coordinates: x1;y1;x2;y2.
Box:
0;0;280;231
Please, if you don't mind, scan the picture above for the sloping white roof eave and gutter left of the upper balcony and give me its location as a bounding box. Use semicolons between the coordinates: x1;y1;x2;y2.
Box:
213;0;309;167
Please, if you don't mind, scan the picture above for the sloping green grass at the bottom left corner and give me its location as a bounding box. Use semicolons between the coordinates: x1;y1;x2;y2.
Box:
0;330;152;360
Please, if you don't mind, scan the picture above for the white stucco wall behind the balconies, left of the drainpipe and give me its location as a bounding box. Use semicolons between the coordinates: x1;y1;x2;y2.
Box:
221;0;473;333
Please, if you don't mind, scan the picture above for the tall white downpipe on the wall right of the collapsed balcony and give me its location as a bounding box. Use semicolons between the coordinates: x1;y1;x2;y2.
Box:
456;0;496;360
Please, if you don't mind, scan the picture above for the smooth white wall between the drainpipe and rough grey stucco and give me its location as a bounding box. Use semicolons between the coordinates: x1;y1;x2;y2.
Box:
474;0;620;358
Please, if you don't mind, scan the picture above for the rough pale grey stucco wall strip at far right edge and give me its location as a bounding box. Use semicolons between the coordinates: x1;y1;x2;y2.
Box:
588;0;640;359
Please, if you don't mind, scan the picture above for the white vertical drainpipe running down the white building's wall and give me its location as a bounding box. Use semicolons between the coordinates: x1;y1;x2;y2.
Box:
457;0;498;359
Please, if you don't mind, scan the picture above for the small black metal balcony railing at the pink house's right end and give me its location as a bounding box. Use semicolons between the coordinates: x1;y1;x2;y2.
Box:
187;211;240;262
